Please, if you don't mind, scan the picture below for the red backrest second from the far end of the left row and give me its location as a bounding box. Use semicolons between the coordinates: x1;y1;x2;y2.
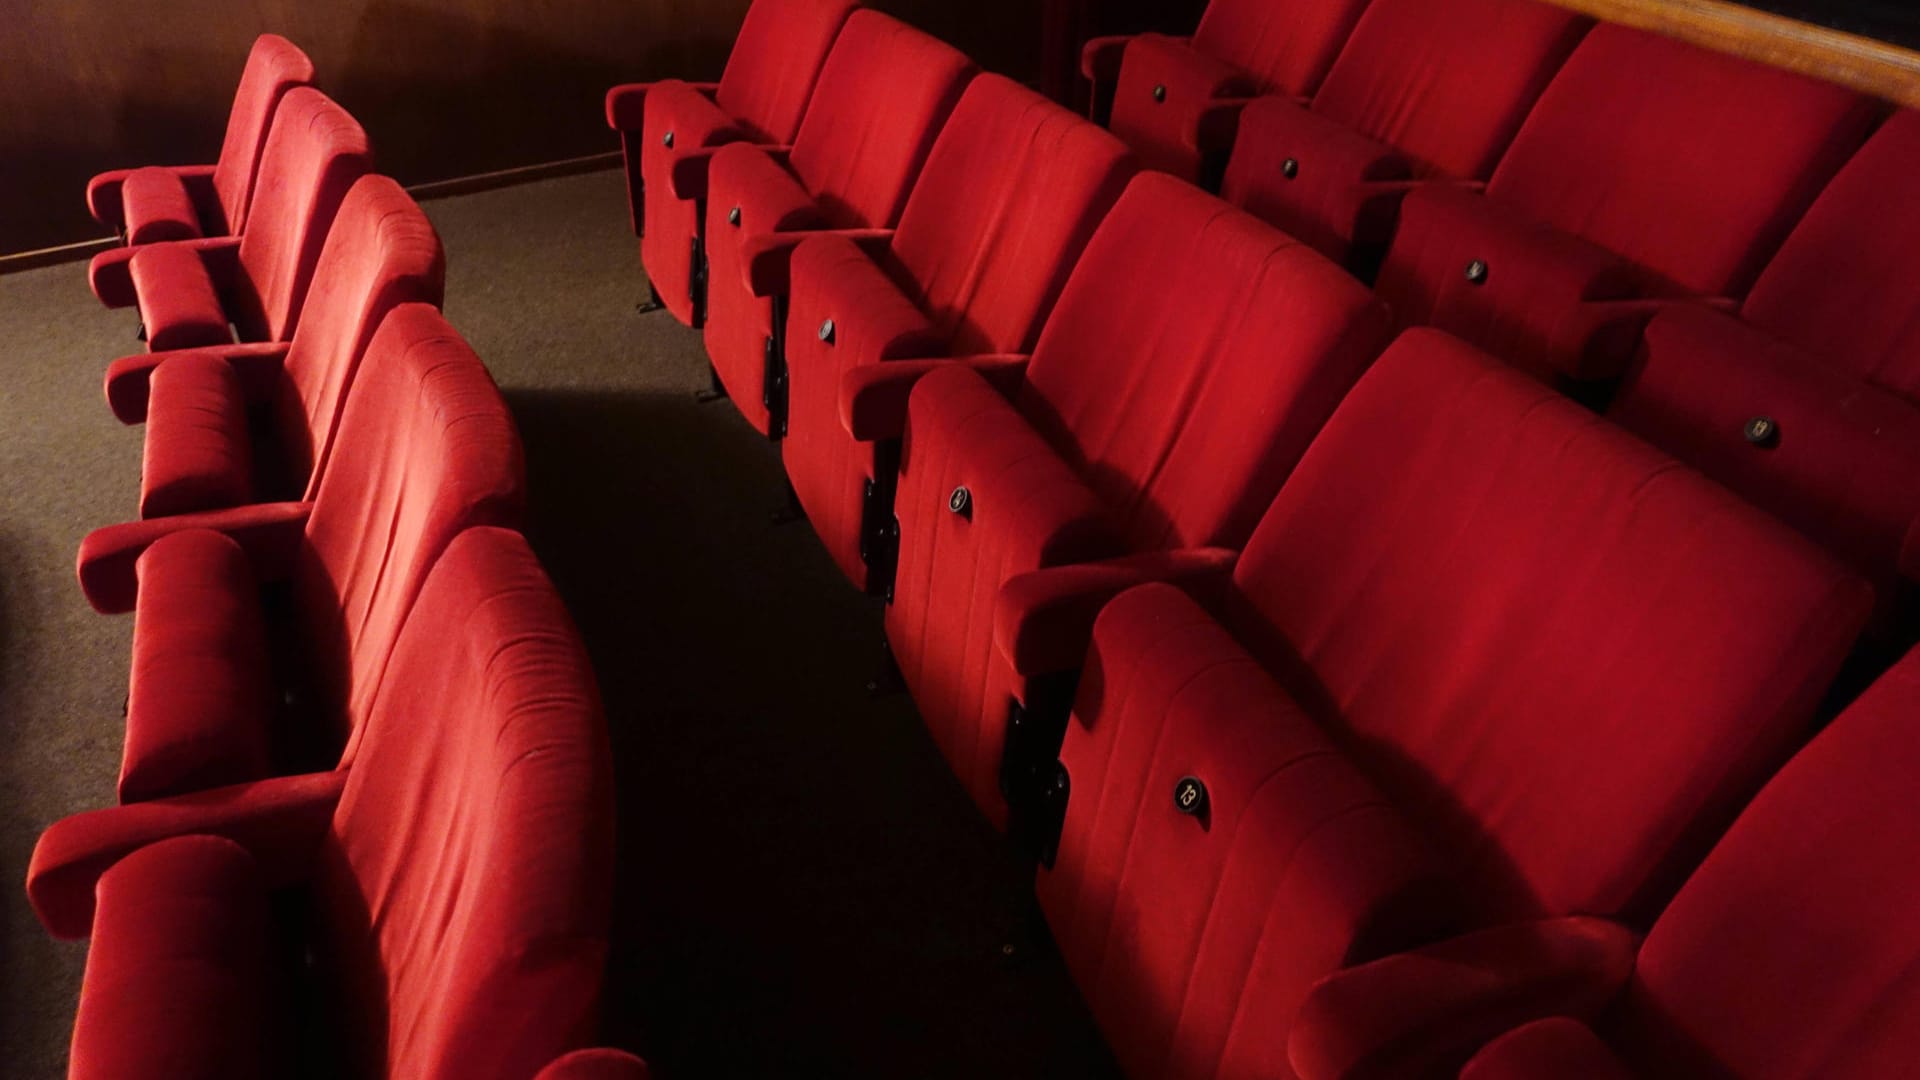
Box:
228;86;372;342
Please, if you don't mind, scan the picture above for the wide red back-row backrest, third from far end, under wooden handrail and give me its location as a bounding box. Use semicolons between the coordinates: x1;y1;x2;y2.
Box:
1486;23;1876;296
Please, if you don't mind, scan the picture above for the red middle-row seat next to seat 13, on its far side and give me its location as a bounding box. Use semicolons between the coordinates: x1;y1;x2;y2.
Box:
881;173;1388;822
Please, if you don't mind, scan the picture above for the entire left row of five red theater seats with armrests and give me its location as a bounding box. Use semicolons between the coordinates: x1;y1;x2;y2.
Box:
27;35;645;1080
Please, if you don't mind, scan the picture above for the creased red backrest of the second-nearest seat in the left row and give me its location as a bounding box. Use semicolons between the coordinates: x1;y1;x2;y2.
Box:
292;304;526;749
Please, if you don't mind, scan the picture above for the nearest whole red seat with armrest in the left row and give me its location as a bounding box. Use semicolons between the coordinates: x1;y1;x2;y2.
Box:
27;528;610;1080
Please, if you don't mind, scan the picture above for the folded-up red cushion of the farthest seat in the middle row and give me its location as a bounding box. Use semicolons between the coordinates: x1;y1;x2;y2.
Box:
639;79;751;327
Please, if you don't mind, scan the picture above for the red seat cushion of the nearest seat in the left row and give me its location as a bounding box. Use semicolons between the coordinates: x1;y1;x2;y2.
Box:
67;836;273;1080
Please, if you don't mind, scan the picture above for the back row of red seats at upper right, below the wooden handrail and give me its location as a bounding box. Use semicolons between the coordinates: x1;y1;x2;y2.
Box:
1083;0;1920;638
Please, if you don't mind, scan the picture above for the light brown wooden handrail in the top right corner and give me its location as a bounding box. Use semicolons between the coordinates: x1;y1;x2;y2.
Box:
1546;0;1920;108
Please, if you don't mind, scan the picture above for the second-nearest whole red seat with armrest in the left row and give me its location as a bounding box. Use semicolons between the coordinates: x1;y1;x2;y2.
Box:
79;304;524;801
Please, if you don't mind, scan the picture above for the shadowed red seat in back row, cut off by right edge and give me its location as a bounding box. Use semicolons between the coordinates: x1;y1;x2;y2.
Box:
1609;111;1920;614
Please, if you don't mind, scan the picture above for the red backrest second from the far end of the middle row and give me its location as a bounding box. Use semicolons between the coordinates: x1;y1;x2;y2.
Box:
791;10;973;229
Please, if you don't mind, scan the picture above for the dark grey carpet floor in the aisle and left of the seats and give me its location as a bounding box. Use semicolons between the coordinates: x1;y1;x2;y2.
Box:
0;171;1112;1078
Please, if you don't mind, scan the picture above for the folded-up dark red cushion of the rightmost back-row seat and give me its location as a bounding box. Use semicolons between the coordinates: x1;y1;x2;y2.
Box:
1609;306;1920;600
